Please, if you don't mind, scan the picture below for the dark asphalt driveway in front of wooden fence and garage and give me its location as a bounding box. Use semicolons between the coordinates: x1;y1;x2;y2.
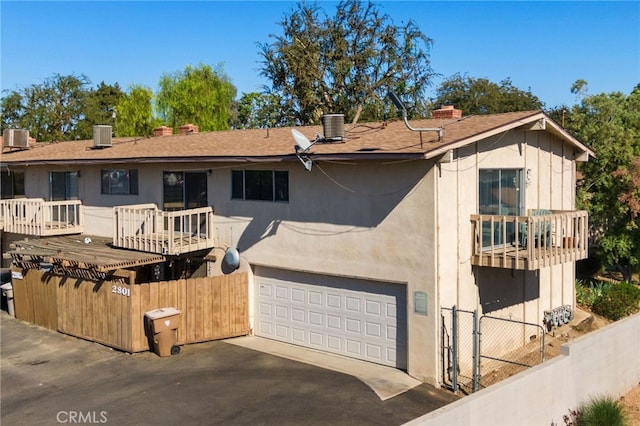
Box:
0;312;457;425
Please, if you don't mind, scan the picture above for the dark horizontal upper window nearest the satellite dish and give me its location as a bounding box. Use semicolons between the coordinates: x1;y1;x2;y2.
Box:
231;170;289;201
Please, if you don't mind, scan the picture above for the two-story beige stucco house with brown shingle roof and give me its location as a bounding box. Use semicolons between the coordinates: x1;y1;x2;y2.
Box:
0;107;593;384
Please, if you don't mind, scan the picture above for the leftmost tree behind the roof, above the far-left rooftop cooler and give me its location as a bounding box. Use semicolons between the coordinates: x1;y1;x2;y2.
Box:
2;74;90;141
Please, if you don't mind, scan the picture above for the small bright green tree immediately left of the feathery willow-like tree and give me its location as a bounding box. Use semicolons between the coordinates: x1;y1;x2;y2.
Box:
115;85;155;136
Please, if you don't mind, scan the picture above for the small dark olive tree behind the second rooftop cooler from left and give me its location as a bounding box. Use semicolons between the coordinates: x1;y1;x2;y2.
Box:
77;82;125;139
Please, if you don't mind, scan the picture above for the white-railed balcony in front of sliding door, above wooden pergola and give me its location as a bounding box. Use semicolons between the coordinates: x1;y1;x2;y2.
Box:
113;204;214;255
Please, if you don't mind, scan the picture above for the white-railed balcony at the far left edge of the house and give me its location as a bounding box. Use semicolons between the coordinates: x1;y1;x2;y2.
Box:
0;198;83;237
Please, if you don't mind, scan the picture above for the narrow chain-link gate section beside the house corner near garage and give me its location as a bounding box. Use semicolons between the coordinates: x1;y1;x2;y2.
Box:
440;306;478;393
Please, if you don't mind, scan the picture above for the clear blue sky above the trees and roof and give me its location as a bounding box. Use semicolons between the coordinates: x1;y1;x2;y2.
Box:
0;0;640;107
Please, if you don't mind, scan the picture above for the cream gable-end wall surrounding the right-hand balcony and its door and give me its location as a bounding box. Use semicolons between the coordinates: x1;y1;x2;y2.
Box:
436;130;575;324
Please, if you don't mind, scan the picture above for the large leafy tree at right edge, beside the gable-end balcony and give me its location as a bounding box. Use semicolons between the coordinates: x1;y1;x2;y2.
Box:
566;82;640;281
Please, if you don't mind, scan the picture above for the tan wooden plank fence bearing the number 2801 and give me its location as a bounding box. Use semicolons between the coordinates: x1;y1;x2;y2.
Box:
12;267;249;352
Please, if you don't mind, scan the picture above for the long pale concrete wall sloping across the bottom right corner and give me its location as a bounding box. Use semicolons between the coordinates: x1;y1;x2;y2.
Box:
407;314;640;426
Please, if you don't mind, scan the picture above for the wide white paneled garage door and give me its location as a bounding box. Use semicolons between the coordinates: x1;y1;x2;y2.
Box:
255;268;407;368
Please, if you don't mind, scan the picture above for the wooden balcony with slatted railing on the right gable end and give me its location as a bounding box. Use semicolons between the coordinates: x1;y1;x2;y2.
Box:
471;210;588;271
